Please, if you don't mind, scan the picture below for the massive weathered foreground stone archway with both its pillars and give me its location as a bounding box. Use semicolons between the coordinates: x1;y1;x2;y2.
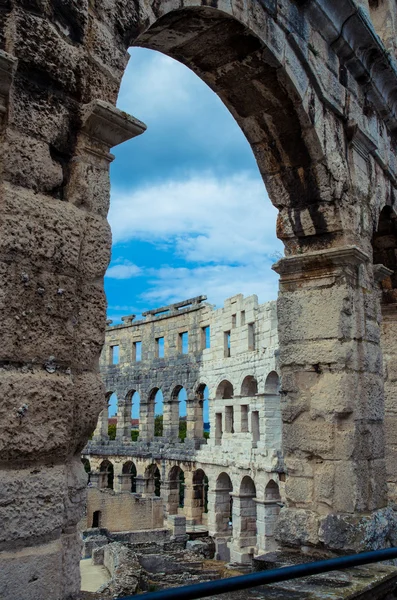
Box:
0;0;397;600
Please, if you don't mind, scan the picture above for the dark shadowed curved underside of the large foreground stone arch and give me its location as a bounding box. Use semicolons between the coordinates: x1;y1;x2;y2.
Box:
128;1;322;246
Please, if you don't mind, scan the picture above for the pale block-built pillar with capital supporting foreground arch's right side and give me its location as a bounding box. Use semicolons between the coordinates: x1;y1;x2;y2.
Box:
274;246;386;551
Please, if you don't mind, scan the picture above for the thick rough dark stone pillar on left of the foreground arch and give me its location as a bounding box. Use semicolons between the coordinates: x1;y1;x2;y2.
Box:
0;44;144;600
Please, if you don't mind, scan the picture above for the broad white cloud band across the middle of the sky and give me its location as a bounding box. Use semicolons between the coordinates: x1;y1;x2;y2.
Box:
109;174;282;264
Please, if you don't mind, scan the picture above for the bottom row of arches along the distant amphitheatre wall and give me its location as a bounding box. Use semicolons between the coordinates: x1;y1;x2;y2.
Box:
84;459;281;562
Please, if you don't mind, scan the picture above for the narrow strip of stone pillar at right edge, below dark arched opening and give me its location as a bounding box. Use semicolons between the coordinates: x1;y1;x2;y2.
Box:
381;304;397;503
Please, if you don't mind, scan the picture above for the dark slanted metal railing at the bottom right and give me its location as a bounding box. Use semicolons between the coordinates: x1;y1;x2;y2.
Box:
119;548;397;600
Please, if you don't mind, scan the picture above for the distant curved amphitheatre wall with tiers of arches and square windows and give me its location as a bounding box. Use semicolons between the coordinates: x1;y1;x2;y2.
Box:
84;295;283;562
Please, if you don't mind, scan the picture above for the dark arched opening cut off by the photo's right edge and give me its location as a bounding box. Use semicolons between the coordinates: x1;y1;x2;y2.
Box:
372;206;397;304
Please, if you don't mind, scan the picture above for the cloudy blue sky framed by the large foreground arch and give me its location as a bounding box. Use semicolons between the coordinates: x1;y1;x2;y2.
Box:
105;48;282;322
